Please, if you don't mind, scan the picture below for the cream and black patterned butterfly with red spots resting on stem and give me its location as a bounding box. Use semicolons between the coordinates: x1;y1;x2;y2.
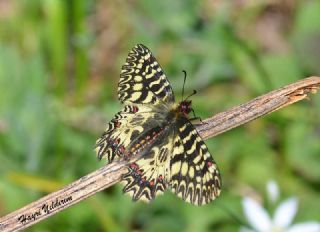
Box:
95;44;221;205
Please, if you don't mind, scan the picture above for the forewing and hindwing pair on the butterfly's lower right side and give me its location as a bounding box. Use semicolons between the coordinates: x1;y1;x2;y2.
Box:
123;118;221;205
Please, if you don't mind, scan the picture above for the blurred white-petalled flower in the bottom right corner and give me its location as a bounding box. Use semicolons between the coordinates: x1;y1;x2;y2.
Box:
240;188;320;232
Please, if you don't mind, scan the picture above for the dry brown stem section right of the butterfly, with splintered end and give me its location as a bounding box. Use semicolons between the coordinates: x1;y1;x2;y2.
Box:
197;77;320;139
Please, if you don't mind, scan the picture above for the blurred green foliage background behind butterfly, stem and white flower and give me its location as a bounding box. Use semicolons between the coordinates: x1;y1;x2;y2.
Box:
0;0;320;232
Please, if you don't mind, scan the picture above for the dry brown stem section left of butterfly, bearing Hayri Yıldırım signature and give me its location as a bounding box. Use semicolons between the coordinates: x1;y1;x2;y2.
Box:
0;162;126;231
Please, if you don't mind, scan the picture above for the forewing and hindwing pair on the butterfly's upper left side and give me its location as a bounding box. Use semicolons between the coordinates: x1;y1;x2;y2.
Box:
96;44;174;163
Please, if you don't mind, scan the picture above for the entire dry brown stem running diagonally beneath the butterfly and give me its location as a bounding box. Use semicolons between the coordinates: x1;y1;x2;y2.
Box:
0;77;320;232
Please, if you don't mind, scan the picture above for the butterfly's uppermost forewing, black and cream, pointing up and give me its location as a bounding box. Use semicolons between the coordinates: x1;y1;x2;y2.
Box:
118;44;174;105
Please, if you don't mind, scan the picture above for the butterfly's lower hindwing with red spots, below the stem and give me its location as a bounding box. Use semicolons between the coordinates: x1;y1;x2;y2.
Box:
122;127;173;202
